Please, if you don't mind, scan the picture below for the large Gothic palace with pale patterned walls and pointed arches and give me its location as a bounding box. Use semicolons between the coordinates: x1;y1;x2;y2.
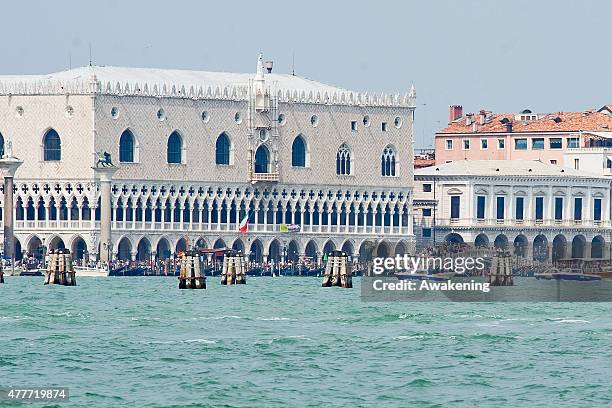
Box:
0;56;416;261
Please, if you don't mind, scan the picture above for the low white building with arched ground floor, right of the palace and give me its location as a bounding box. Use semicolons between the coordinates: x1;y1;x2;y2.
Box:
414;160;612;260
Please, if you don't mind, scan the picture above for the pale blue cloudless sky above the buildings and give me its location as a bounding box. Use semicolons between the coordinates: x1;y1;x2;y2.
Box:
0;0;612;147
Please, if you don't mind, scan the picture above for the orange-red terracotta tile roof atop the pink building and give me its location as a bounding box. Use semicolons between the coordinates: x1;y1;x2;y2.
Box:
438;111;612;134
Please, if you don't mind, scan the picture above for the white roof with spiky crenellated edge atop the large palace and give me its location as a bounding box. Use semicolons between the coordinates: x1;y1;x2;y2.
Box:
0;62;416;109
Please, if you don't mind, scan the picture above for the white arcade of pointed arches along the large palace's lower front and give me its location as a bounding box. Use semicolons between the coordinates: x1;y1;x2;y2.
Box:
5;180;411;260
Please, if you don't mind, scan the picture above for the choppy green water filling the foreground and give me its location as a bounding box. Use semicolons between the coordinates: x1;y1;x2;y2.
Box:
0;277;612;407
